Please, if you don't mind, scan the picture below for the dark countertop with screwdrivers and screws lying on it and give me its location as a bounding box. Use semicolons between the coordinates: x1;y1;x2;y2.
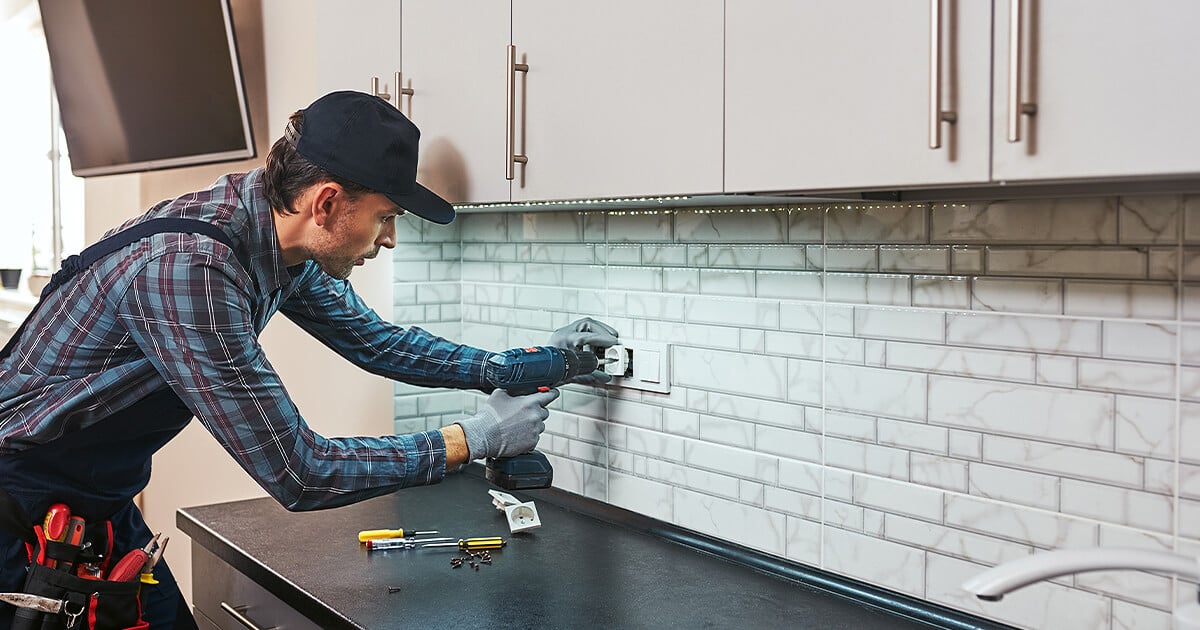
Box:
176;466;945;630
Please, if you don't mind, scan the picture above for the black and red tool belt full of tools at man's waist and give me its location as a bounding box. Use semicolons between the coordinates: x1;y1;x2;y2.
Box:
0;490;150;630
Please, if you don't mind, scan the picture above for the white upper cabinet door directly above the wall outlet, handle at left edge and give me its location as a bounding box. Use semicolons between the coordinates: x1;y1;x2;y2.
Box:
508;0;722;200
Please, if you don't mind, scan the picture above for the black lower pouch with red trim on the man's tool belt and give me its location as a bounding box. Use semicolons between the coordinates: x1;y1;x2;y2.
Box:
18;563;150;630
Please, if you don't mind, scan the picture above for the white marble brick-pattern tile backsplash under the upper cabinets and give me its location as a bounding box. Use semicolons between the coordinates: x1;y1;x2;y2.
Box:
394;194;1200;630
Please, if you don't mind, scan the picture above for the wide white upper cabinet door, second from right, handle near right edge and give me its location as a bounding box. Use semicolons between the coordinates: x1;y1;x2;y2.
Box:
725;0;991;192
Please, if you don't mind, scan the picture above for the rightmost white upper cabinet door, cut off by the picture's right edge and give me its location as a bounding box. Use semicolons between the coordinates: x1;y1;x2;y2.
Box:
992;0;1200;181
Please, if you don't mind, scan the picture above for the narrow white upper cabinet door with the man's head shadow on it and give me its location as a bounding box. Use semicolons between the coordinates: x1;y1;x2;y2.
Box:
400;0;510;203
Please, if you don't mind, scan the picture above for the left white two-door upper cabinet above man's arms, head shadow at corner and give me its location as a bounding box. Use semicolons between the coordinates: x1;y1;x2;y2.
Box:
402;0;724;202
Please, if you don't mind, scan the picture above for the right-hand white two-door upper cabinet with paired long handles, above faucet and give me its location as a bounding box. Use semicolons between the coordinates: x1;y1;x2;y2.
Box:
725;0;1200;192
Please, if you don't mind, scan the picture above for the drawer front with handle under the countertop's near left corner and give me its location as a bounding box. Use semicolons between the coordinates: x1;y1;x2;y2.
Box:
192;544;320;630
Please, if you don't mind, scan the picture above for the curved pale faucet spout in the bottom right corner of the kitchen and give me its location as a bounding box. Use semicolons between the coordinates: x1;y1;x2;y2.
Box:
962;547;1200;630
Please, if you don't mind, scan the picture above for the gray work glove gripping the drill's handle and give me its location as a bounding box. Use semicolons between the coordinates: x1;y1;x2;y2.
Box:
458;389;558;460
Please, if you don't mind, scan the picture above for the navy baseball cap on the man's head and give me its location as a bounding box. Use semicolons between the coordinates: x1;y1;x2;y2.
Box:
294;91;454;224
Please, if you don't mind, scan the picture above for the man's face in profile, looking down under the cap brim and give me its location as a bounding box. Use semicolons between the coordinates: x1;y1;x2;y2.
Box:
312;192;404;280
